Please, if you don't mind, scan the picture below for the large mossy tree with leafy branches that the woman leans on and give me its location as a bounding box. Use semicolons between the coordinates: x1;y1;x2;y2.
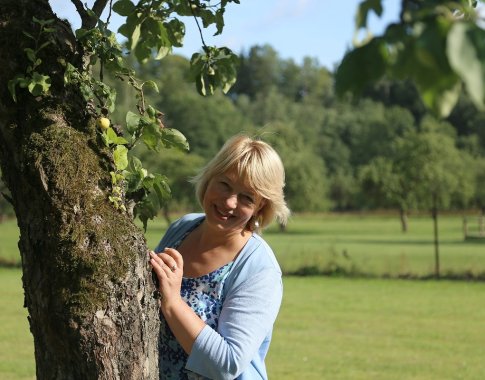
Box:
0;0;237;379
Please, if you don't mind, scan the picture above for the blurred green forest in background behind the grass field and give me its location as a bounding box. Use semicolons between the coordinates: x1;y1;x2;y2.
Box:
0;45;485;230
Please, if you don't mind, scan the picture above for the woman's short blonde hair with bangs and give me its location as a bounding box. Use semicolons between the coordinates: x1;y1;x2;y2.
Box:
191;135;290;230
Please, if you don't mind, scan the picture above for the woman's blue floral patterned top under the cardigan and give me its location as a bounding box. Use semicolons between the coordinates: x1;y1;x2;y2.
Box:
159;224;234;380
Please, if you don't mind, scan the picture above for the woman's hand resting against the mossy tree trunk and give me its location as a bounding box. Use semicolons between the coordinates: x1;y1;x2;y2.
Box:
150;248;184;307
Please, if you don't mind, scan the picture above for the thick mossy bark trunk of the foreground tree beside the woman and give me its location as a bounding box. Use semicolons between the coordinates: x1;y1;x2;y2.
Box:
0;0;159;379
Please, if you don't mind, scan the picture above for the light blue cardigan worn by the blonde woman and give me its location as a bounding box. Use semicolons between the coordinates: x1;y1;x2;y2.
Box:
155;214;283;380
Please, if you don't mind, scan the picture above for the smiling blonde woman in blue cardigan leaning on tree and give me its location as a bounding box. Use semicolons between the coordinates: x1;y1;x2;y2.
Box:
150;136;289;379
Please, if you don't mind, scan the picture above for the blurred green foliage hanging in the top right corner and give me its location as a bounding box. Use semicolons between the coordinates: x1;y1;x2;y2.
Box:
336;0;485;116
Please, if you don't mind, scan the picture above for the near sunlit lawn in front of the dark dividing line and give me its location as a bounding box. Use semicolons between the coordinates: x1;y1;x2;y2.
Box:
0;269;485;380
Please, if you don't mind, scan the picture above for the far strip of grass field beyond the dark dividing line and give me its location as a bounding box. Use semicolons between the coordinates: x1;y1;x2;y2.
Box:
0;214;485;277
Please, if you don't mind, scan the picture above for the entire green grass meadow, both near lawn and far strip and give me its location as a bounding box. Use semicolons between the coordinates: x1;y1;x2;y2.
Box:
0;215;485;380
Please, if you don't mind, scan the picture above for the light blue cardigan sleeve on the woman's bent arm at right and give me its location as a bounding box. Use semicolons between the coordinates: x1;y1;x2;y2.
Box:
186;268;283;379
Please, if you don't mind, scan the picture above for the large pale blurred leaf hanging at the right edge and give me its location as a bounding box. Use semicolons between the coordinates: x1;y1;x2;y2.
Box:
446;22;485;109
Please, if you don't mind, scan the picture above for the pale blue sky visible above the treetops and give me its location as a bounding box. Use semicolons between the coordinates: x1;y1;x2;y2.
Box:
49;0;400;70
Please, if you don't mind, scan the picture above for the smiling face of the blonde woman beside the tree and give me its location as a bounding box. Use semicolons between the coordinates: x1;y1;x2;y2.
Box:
203;170;264;232
